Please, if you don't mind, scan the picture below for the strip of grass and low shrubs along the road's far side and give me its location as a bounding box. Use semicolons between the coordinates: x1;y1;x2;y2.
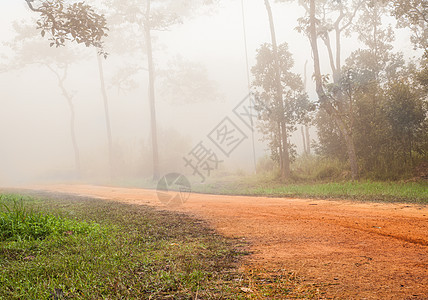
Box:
187;156;428;204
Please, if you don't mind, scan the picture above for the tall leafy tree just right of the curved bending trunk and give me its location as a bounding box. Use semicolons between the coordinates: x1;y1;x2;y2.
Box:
344;2;405;174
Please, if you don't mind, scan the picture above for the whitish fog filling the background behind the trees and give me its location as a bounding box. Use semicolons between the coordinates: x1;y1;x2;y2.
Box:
0;0;418;186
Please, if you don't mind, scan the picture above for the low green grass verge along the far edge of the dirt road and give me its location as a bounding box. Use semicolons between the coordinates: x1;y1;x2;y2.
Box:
192;176;428;204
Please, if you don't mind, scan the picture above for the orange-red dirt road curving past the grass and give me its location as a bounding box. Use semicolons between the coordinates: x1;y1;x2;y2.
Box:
25;185;428;299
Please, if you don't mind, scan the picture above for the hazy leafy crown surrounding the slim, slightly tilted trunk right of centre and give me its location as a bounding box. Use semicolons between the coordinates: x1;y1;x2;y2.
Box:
251;43;313;179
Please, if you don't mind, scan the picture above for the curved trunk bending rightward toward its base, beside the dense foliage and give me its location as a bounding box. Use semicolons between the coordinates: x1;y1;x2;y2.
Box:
309;0;358;180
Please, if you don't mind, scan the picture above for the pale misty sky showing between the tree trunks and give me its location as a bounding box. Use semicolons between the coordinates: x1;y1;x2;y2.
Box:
0;0;422;185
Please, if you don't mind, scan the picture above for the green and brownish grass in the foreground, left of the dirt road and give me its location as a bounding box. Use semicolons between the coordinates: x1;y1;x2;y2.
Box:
0;194;315;299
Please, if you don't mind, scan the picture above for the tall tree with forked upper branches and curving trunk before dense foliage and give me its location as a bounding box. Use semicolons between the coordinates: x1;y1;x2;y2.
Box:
279;0;364;179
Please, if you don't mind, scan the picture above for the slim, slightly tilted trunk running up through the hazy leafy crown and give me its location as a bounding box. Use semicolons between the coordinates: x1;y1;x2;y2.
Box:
265;0;290;179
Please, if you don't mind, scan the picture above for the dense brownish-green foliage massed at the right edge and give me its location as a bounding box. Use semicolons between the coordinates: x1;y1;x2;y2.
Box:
310;3;428;180
